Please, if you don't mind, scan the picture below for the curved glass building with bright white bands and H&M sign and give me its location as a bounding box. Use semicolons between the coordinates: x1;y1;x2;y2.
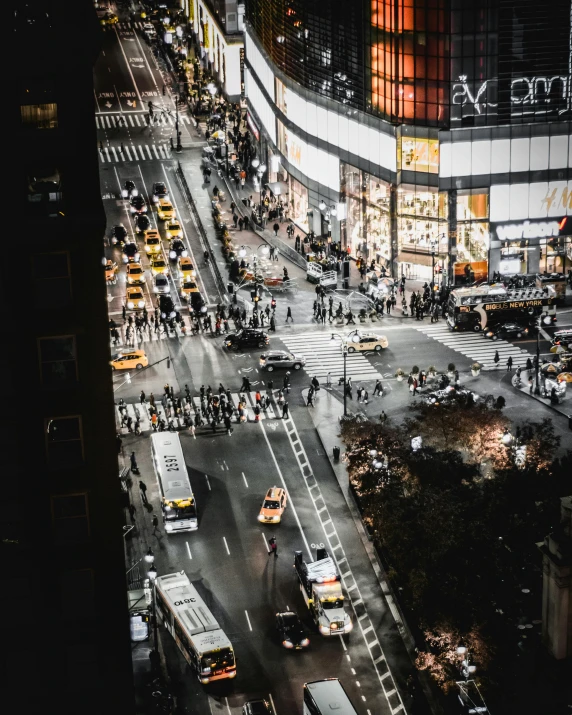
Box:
245;0;572;284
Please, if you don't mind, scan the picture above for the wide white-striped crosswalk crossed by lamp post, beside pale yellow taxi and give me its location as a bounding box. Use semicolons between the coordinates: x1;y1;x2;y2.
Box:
280;332;381;382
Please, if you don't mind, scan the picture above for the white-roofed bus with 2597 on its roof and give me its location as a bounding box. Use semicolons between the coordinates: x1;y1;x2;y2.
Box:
151;432;199;534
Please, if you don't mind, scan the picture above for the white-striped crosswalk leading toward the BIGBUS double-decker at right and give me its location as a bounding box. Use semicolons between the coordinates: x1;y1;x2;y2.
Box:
416;323;532;370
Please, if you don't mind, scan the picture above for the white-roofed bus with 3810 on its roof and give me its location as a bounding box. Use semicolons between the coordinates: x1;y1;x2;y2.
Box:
155;571;236;684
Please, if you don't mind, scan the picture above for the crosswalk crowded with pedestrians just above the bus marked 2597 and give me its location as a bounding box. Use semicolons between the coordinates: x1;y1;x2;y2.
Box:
115;390;282;434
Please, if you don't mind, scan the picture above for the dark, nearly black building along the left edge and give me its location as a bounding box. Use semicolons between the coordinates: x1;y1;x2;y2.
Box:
0;0;135;715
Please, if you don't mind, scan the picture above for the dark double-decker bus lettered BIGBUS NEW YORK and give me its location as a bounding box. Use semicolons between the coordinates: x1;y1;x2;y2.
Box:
447;285;556;332
